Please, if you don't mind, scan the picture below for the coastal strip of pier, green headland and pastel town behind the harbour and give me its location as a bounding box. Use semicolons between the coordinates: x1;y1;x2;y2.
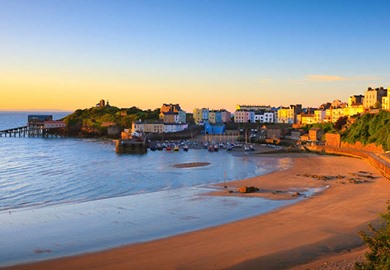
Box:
0;87;390;156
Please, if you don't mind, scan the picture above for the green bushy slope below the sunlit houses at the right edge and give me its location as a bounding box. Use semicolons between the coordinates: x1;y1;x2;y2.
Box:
342;111;390;151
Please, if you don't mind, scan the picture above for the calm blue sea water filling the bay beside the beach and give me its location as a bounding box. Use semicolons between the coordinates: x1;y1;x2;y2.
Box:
0;111;318;266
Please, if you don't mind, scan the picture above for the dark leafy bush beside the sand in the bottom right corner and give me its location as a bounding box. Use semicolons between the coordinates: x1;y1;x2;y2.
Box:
355;204;390;270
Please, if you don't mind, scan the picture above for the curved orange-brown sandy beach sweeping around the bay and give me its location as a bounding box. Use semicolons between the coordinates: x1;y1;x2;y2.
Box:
3;154;390;269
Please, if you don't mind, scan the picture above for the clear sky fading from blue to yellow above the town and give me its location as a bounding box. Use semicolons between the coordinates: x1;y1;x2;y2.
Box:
0;0;390;112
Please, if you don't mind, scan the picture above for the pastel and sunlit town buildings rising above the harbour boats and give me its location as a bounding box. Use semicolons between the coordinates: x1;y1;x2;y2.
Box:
102;87;390;154
